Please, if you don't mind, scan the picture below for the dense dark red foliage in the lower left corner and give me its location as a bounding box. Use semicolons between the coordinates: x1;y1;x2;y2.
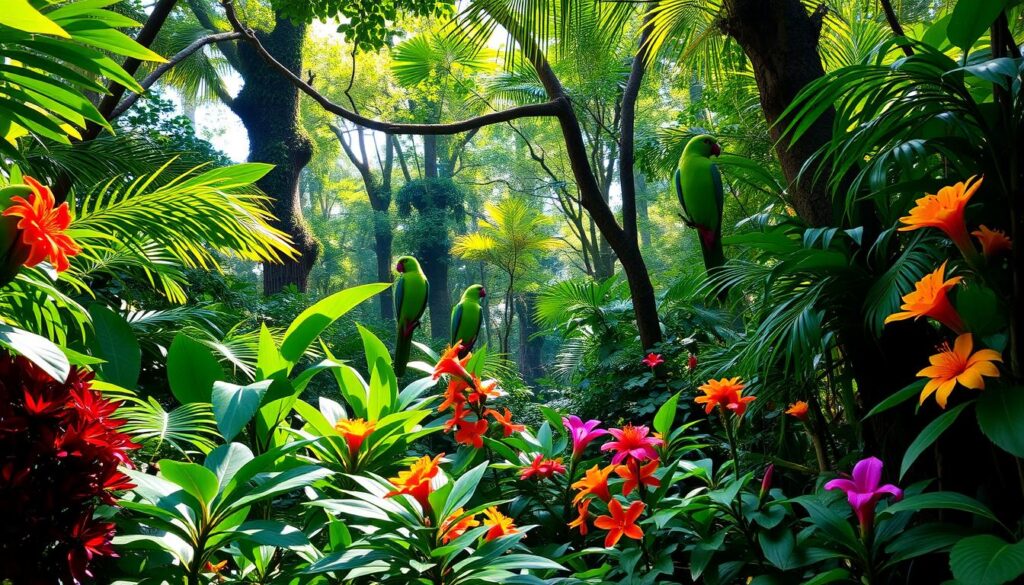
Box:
0;351;137;585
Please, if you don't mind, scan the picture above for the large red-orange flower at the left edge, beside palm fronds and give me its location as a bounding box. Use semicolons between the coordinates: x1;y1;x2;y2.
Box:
3;176;82;273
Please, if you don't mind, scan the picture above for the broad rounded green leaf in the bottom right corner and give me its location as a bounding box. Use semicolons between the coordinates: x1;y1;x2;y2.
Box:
949;534;1024;585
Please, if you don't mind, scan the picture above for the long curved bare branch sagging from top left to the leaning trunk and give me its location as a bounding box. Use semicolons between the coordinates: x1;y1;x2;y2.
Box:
220;0;569;136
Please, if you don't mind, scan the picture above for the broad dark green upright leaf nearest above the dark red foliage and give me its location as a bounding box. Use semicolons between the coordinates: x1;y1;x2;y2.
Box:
89;303;142;388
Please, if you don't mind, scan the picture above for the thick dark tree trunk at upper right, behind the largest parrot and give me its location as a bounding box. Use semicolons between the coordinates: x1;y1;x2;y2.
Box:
722;0;835;226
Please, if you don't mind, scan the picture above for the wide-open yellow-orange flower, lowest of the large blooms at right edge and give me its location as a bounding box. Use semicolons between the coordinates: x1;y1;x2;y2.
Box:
918;333;1002;408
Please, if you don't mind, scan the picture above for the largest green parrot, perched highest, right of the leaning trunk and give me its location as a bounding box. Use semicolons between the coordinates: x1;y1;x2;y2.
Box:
675;134;725;270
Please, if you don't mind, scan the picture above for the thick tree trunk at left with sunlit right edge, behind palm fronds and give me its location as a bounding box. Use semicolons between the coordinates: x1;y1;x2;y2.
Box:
231;17;318;295
